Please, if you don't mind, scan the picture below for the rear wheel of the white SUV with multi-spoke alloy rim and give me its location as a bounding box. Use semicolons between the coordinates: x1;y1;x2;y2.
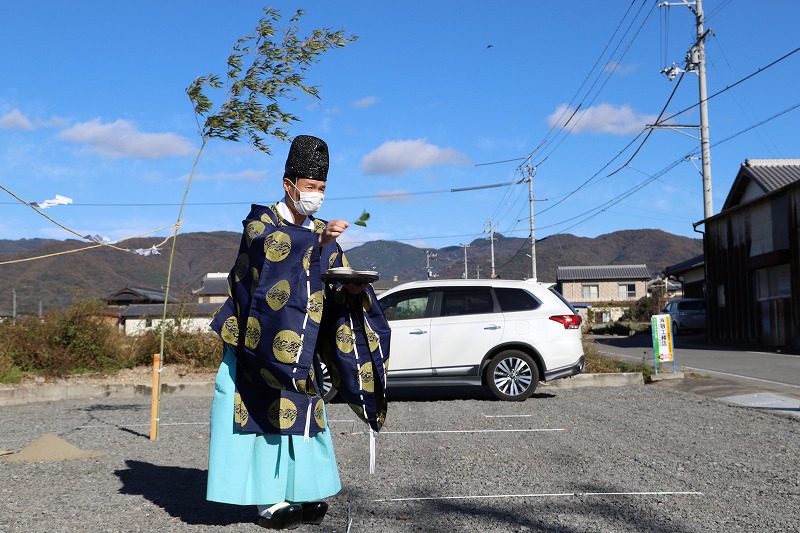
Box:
486;350;539;402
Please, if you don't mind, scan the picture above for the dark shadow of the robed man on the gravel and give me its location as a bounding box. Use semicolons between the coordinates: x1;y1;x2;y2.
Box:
114;460;255;525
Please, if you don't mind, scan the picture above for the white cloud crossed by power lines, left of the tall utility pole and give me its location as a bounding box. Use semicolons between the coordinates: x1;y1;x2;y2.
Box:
547;104;657;135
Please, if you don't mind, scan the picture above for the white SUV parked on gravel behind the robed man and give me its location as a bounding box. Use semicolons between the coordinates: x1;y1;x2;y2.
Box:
378;279;585;401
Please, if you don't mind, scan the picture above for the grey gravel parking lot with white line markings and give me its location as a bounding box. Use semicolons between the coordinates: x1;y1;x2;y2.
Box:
0;385;800;533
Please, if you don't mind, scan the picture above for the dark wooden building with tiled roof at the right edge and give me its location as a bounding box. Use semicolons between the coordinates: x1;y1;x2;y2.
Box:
703;159;800;350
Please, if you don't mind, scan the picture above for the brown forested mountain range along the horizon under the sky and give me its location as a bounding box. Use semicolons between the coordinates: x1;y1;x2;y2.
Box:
0;229;703;316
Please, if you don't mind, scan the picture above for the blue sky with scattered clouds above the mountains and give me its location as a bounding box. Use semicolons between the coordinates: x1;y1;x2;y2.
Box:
0;0;800;248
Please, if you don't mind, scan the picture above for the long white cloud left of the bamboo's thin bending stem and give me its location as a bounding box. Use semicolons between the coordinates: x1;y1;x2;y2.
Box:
59;118;194;159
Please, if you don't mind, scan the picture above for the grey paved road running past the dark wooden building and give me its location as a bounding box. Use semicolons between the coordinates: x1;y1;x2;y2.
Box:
595;335;800;398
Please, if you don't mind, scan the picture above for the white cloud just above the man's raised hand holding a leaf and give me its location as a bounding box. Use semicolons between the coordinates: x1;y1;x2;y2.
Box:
361;139;469;174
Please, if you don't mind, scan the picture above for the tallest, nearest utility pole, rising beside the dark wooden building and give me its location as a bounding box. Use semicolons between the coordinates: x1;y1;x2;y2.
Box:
659;0;714;218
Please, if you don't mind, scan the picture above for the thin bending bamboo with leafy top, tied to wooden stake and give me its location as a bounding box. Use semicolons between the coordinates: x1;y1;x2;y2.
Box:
150;7;357;440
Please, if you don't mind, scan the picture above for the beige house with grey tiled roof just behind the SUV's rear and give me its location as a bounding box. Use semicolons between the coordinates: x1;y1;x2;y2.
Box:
556;265;650;322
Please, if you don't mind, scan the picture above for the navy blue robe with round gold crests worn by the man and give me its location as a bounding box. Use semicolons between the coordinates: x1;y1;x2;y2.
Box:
211;204;390;436
